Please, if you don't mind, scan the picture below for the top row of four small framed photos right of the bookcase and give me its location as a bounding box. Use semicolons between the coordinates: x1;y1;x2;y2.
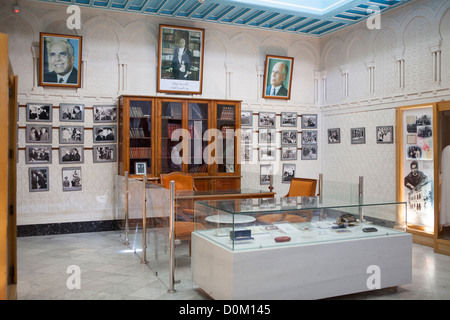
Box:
241;110;317;129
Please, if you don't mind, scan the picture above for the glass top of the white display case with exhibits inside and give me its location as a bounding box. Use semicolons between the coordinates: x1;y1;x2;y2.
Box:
194;197;406;251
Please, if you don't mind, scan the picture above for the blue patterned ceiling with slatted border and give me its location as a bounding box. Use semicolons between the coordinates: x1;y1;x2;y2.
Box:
29;0;413;37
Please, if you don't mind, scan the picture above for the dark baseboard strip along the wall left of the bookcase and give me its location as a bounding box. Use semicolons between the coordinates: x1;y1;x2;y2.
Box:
17;220;120;237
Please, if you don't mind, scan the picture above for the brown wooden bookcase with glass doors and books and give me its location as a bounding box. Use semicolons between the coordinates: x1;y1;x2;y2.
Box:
118;95;241;190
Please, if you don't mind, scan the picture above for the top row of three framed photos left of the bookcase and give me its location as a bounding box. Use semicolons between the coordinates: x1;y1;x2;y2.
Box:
26;102;117;123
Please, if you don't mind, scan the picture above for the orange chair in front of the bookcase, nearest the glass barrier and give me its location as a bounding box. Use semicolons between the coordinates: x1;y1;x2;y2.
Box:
160;172;205;255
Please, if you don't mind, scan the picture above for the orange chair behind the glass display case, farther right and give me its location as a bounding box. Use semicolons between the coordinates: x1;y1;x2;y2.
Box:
256;178;317;224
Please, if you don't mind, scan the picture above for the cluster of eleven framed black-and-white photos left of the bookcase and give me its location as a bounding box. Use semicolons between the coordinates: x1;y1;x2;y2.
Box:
23;103;117;192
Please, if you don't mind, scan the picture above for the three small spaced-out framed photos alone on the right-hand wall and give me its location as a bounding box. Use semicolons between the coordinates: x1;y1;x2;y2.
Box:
328;126;394;144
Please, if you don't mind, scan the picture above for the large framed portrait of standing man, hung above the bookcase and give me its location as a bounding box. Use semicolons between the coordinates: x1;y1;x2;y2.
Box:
157;25;205;94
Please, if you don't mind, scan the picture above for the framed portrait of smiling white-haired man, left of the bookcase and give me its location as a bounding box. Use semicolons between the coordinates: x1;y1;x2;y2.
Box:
39;32;82;88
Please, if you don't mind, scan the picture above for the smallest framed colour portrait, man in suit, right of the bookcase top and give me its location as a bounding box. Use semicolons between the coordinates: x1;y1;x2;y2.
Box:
263;55;294;100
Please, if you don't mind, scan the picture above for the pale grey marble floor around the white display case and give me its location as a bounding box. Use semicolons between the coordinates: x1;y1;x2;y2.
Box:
17;231;450;300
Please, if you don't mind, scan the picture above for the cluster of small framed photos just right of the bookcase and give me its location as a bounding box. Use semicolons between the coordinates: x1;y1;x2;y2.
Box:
241;110;318;185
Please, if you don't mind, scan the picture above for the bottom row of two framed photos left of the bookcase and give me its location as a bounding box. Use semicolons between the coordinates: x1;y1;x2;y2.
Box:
28;167;83;192
